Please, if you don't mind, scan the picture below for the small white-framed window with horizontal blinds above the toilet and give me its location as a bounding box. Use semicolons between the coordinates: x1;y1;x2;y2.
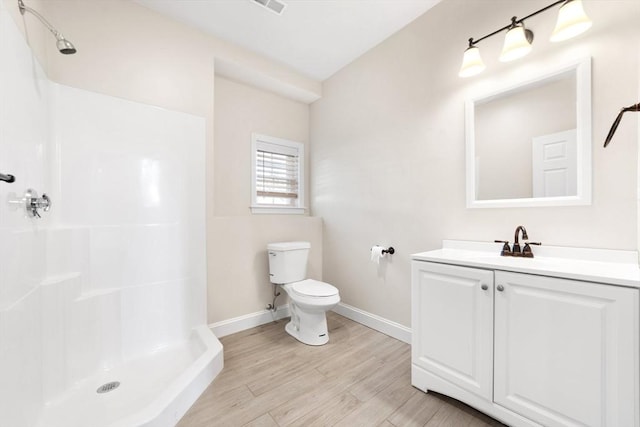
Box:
251;134;304;213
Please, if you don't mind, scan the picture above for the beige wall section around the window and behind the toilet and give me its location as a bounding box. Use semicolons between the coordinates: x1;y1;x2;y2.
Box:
207;76;322;323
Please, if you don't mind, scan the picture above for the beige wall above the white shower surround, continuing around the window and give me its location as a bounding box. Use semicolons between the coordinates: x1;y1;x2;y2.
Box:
2;0;322;321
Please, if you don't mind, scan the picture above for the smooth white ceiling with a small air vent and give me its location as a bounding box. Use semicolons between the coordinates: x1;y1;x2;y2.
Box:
134;0;440;81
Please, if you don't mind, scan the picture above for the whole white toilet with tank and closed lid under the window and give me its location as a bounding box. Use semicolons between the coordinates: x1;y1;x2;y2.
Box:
267;242;340;345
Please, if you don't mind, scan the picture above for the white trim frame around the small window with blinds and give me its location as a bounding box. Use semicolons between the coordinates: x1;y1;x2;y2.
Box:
250;133;307;215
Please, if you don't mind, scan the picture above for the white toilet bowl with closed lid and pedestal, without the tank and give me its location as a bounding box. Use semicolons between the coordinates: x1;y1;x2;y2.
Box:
282;279;340;345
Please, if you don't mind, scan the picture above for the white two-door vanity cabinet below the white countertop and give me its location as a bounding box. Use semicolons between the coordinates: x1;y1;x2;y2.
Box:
412;257;640;427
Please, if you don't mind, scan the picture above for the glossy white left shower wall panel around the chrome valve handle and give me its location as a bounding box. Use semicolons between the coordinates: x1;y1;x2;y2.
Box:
0;5;49;426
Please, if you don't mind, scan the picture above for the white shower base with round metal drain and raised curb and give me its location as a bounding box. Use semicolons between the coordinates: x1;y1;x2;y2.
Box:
37;326;223;427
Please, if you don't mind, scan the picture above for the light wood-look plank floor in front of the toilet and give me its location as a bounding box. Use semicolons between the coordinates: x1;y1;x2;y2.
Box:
178;312;503;427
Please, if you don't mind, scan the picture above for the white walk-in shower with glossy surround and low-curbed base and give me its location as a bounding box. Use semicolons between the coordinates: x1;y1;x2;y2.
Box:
0;2;222;427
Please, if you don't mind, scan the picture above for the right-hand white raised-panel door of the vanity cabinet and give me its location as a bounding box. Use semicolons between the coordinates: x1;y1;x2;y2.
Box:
494;272;639;427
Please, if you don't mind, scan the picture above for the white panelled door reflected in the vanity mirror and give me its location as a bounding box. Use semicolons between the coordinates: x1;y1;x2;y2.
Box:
532;129;578;197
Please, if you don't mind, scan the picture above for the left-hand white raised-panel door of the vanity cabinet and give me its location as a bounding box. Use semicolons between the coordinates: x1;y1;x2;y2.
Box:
411;261;493;400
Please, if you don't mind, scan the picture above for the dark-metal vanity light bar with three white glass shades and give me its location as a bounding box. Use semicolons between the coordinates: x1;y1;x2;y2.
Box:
458;0;591;77
